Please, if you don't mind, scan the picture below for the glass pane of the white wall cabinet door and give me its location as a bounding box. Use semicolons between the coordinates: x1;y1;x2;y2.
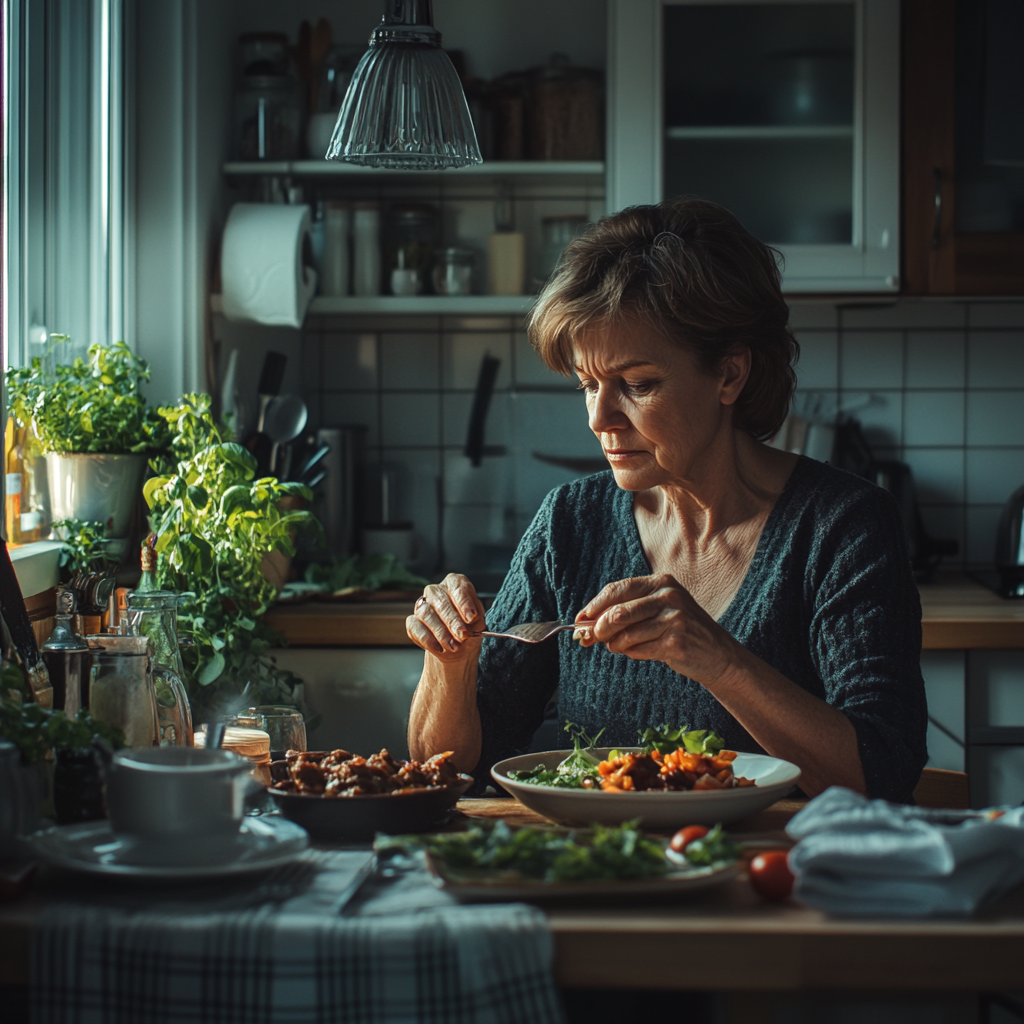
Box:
662;2;856;246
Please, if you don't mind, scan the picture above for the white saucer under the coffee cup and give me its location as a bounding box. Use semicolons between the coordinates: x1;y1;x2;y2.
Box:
26;817;309;882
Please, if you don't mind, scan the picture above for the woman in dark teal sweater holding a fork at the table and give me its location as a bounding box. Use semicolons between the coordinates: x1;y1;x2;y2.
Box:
407;193;927;801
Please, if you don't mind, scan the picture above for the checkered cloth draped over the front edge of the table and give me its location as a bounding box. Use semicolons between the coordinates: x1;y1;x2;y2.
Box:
31;851;562;1024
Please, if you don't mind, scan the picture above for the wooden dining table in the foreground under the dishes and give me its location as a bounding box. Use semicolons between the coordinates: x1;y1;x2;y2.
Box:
0;799;1024;993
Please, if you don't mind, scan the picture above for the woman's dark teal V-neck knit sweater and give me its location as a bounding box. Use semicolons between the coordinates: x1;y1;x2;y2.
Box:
475;458;928;801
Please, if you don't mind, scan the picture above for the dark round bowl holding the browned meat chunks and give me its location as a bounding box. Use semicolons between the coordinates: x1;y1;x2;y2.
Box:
266;761;473;842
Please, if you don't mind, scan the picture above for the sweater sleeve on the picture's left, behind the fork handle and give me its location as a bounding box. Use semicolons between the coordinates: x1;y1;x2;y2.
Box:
473;495;559;788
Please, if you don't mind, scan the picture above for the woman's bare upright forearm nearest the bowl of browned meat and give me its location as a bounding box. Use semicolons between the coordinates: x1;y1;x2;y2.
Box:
409;653;480;772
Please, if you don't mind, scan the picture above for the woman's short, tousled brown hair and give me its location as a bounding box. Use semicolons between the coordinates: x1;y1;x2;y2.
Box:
527;199;800;440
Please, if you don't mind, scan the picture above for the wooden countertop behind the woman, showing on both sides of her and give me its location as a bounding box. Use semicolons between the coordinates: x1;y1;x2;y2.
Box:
266;573;1024;650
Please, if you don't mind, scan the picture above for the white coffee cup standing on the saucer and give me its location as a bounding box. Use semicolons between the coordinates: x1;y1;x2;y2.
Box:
106;746;259;866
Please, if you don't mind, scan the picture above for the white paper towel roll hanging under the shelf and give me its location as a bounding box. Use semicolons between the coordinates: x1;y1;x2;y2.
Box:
220;203;316;327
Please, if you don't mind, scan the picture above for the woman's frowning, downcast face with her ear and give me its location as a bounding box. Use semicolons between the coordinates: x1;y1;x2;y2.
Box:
573;326;750;490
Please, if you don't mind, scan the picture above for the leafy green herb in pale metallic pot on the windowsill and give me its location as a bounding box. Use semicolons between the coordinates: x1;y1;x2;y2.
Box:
5;335;167;538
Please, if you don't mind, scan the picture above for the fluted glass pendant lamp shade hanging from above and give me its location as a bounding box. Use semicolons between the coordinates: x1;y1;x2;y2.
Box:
327;0;483;171
